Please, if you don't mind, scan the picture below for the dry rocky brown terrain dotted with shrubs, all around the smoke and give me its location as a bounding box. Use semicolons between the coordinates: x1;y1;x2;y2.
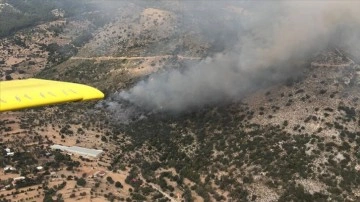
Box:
0;1;360;201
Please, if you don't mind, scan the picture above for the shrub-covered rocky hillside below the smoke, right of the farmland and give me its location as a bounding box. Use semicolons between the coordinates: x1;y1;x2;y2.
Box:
100;49;360;201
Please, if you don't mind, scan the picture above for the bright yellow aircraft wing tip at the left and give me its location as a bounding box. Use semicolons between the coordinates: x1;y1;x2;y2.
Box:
0;79;104;112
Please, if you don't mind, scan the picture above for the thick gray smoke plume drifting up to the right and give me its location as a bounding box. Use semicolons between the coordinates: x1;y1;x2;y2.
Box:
115;1;360;112
